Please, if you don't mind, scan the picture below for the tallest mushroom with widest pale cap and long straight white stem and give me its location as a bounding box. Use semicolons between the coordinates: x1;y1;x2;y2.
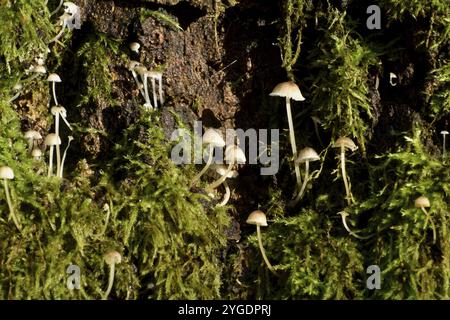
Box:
270;81;305;188
